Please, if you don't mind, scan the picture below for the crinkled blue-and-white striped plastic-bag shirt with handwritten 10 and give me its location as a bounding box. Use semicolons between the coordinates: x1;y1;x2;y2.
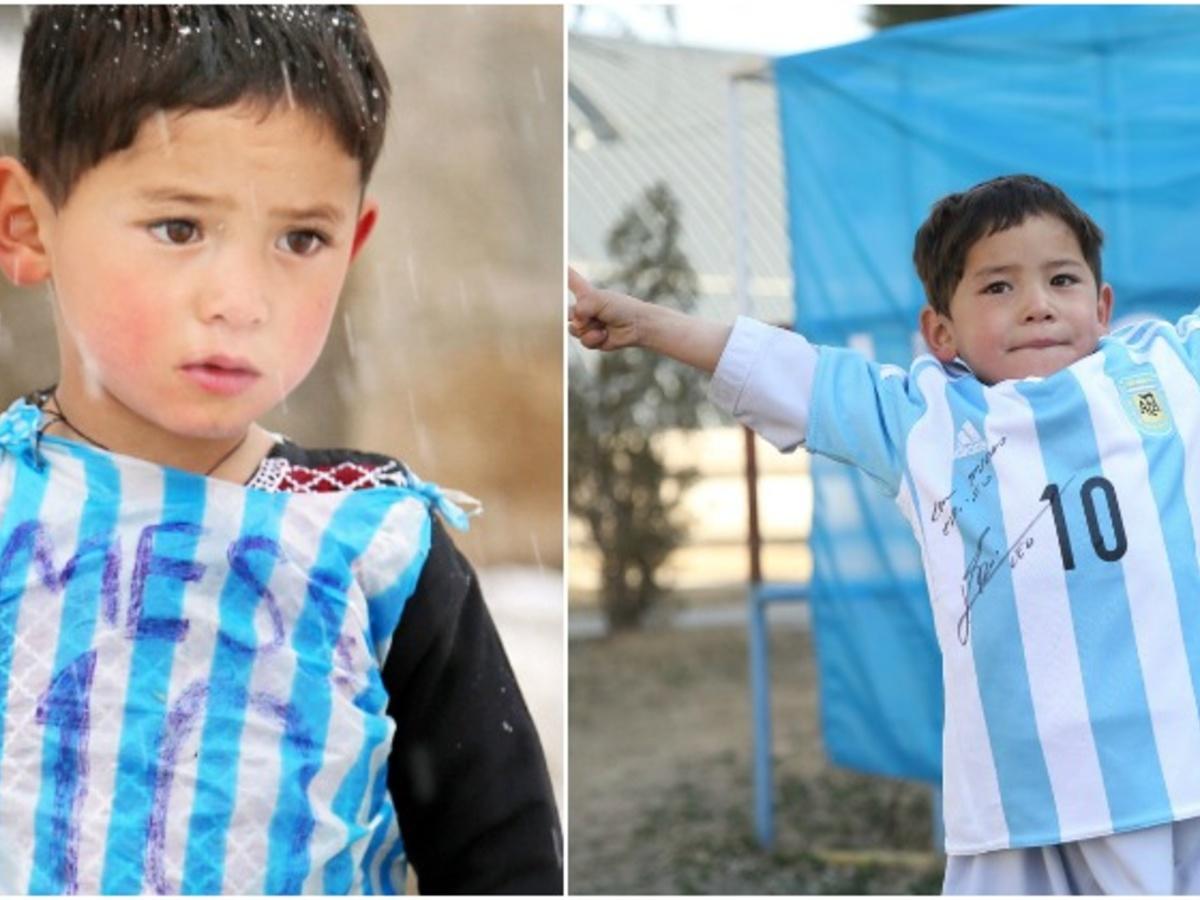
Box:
0;401;451;894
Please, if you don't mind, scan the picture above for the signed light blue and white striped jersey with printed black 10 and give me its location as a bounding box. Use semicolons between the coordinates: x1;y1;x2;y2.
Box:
710;316;1200;853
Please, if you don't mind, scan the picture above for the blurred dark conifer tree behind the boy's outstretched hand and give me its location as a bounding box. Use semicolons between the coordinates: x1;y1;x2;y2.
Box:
568;182;703;630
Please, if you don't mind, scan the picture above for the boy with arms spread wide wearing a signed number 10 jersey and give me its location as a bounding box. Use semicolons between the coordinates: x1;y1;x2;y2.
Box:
570;175;1200;893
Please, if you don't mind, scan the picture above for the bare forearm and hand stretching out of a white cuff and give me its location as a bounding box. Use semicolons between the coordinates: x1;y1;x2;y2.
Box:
566;269;731;373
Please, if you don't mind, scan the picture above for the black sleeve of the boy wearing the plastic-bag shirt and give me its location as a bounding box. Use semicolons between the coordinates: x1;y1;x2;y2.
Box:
383;520;563;894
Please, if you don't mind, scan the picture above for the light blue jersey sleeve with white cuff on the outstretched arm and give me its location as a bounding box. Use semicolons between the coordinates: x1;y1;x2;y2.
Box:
709;318;924;496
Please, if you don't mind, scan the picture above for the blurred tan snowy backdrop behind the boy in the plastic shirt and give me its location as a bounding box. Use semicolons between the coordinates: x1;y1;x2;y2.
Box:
0;6;563;816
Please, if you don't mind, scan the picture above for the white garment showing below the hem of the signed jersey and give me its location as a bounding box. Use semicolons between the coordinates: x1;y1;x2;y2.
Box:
942;818;1200;894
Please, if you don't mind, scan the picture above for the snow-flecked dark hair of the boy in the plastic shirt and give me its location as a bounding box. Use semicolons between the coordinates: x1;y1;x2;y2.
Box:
19;6;390;206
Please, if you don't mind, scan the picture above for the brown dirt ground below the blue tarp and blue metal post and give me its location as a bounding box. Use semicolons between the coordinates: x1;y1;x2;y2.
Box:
568;626;942;894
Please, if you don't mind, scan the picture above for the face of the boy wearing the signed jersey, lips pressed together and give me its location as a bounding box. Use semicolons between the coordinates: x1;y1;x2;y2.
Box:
920;216;1112;384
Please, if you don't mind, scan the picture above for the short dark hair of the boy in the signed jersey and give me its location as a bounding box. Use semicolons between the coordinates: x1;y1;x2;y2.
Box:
912;175;1104;316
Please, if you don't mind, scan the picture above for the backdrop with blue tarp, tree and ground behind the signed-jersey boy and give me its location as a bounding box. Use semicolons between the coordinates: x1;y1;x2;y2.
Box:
566;2;1200;894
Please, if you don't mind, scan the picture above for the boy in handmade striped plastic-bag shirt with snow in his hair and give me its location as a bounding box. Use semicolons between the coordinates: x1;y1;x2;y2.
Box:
0;6;562;894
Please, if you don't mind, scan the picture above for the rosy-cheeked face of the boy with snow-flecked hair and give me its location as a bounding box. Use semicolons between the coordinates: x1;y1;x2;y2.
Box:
35;104;374;442
